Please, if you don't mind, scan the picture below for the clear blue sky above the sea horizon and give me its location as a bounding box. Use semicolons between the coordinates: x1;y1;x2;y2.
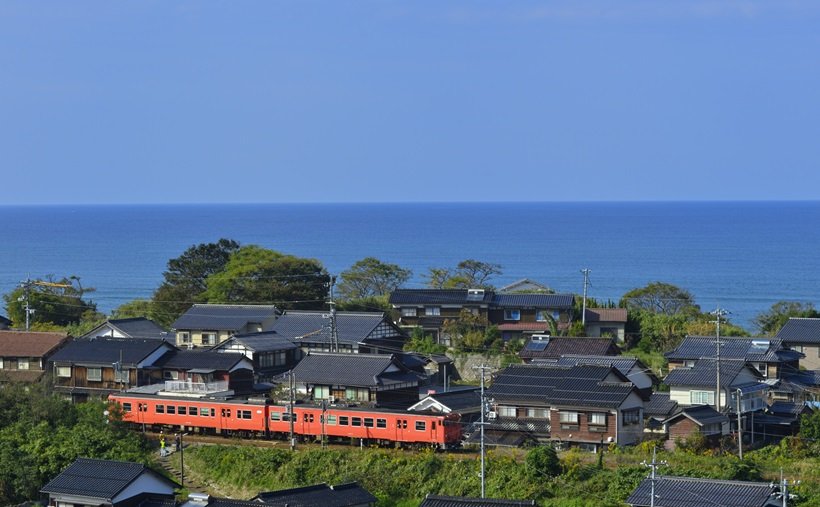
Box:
0;0;820;204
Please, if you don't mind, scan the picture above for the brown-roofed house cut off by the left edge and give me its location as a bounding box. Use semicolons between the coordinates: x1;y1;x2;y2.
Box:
0;330;68;383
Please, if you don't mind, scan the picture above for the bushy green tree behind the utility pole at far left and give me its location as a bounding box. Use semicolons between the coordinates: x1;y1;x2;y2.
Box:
3;275;97;330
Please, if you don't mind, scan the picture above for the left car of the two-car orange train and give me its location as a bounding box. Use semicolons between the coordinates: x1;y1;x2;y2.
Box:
109;393;268;436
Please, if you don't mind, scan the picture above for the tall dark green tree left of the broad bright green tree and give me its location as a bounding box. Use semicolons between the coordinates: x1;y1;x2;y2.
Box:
152;238;239;326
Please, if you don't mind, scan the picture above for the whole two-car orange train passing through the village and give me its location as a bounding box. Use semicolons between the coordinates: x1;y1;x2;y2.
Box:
109;392;462;449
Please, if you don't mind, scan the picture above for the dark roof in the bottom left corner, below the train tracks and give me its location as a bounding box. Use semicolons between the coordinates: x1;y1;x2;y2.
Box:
40;458;175;502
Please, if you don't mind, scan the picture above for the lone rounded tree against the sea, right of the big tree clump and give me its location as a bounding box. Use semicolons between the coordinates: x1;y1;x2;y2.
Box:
339;257;413;300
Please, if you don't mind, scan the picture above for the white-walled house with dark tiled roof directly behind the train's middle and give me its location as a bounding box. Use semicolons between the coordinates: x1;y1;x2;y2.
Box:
285;353;421;408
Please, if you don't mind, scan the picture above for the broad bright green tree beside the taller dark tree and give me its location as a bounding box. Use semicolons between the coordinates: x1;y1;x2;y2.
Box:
203;245;329;310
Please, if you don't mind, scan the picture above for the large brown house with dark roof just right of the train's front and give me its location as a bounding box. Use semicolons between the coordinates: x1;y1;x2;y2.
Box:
488;364;644;450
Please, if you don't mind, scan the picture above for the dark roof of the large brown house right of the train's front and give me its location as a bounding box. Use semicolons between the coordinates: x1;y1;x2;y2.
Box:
488;365;636;408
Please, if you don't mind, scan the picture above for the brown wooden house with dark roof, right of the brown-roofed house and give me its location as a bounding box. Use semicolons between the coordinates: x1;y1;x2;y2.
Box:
49;337;174;401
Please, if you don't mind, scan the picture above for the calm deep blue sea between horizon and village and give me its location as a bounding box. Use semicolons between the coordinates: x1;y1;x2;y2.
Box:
0;202;820;331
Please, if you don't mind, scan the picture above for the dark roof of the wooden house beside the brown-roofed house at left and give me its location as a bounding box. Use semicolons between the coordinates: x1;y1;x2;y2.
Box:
50;337;173;366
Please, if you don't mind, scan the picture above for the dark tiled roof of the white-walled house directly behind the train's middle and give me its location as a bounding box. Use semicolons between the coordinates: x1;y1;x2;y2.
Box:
293;353;419;388
